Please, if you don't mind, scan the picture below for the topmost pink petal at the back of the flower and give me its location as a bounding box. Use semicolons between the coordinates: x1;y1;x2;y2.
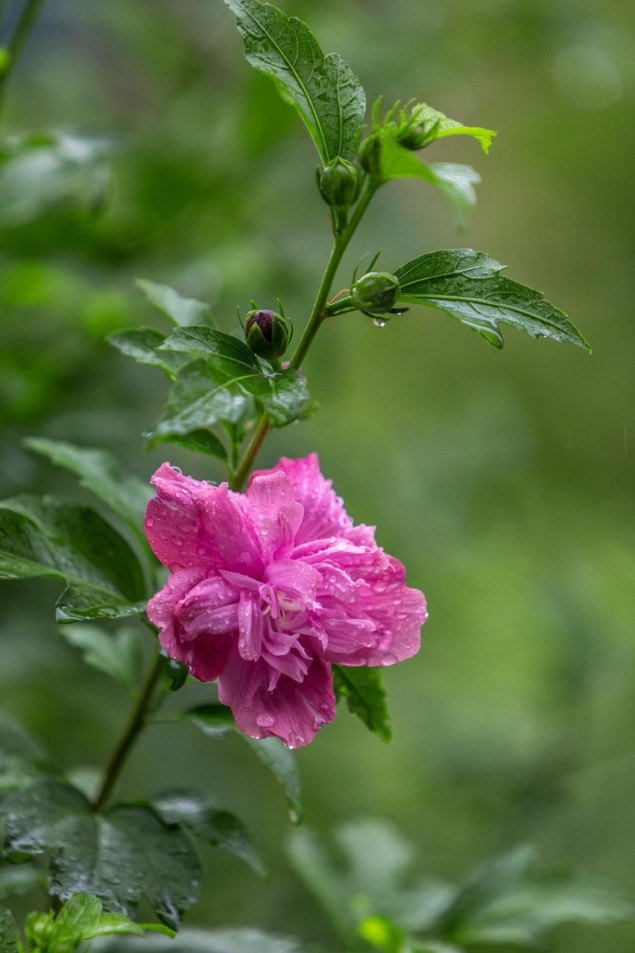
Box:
254;453;353;543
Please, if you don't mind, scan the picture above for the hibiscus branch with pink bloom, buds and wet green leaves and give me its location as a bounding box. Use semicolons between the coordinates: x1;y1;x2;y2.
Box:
0;0;612;953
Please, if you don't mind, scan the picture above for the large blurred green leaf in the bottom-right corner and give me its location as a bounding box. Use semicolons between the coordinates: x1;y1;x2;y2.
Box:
443;848;635;947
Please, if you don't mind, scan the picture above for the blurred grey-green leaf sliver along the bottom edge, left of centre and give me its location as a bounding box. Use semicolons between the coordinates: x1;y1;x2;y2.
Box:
99;929;306;953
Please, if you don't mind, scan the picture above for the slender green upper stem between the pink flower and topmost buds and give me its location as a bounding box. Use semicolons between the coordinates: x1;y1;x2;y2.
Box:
232;180;379;490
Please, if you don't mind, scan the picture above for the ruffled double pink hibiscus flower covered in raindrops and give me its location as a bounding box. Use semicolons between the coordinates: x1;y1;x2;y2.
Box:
146;454;426;748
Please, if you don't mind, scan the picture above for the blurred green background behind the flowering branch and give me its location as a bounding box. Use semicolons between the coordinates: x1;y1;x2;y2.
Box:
0;0;635;953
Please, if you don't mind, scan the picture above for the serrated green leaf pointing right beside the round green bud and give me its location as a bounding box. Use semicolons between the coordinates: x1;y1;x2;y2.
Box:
395;248;591;351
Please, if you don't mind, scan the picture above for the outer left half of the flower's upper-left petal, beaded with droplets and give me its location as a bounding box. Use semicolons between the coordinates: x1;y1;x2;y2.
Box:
145;463;222;572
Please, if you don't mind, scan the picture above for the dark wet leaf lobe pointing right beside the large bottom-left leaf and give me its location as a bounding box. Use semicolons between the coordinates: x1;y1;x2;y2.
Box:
152;791;265;877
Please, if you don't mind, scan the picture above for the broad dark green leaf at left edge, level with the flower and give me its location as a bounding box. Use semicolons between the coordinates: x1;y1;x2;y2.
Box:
0;494;145;622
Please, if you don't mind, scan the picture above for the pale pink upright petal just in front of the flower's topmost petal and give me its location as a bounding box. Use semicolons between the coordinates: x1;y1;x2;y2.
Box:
247;472;304;561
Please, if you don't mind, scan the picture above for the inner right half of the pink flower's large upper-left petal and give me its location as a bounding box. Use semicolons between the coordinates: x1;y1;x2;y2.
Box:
198;483;263;577
